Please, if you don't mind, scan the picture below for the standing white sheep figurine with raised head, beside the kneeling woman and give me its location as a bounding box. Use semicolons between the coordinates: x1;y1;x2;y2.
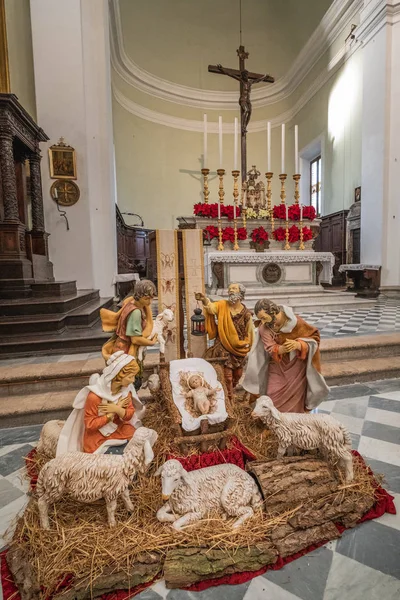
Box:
36;427;158;529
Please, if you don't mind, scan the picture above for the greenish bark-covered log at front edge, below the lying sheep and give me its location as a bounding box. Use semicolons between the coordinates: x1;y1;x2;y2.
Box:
164;541;277;589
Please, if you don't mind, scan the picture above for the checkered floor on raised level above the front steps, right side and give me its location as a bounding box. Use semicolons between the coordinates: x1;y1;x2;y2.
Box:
301;298;400;338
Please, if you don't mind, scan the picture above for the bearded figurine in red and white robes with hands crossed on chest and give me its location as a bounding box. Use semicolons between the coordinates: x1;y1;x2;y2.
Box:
243;298;329;413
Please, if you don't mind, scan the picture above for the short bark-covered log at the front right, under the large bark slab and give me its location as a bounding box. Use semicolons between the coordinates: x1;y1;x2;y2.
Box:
271;523;340;558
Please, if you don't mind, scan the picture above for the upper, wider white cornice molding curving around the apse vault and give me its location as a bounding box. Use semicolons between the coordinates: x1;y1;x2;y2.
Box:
109;0;363;111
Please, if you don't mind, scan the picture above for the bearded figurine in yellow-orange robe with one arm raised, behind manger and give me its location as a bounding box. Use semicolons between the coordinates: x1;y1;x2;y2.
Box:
196;283;253;399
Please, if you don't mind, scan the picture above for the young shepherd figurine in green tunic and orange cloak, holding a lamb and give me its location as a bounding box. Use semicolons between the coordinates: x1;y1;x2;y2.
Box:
100;279;157;383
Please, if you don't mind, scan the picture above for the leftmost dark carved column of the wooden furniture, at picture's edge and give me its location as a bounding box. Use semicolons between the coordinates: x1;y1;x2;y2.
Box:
0;133;19;223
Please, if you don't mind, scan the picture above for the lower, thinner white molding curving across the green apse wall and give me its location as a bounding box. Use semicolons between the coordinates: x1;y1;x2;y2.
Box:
112;43;360;134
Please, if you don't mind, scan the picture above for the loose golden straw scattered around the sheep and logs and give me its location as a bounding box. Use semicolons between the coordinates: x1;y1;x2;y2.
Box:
12;396;374;597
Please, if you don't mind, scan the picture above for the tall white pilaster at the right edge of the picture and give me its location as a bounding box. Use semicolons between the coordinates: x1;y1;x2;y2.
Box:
357;0;400;291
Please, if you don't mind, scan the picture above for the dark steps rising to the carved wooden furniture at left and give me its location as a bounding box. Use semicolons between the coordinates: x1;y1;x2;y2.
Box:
0;281;113;359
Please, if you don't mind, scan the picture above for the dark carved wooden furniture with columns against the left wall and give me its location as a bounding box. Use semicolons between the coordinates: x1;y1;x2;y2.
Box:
0;94;54;297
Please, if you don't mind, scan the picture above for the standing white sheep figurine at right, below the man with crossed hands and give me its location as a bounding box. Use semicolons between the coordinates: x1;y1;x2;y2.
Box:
252;396;353;481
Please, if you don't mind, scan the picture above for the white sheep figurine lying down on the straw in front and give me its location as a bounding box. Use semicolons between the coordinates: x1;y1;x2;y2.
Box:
156;459;262;531
